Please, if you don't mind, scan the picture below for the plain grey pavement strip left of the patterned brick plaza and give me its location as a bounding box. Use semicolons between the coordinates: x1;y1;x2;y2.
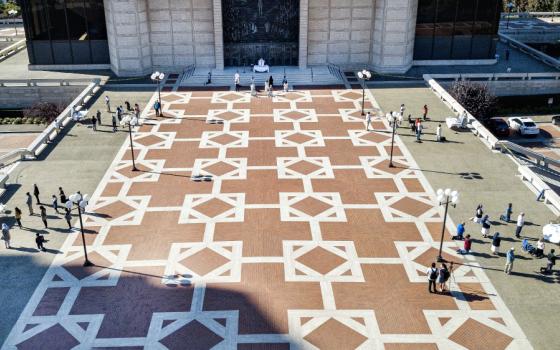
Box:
0;90;151;343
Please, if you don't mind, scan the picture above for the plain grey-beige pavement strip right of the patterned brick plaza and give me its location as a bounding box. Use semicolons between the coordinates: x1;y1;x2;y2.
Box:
371;86;560;350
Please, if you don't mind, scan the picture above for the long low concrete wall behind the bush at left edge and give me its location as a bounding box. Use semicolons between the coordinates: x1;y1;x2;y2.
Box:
0;85;86;109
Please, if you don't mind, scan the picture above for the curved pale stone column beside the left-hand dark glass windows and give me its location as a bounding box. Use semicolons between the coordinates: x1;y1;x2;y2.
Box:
104;0;152;76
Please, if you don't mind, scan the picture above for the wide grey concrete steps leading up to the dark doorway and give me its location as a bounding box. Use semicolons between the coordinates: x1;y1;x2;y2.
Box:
180;66;344;89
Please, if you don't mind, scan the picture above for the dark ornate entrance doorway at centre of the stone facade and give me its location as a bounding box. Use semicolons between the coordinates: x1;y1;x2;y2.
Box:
222;0;299;66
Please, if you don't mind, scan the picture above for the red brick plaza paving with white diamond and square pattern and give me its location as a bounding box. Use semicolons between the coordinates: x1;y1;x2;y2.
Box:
4;89;533;349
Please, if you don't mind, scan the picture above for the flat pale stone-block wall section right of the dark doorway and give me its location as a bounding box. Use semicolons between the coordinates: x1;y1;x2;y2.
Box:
307;0;375;65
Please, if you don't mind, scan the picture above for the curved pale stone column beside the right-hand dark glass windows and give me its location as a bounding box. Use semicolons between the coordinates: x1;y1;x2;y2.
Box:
371;0;418;73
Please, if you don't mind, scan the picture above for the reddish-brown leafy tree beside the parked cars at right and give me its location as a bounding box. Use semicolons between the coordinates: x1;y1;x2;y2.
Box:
449;81;497;122
